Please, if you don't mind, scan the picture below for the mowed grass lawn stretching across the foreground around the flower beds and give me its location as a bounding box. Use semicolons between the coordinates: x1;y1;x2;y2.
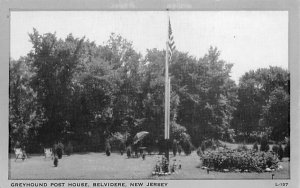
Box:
10;152;290;179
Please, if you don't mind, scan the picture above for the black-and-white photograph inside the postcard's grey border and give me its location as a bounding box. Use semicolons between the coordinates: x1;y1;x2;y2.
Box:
1;0;298;187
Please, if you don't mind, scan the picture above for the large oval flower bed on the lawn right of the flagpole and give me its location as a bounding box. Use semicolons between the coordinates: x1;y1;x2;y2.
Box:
200;149;278;172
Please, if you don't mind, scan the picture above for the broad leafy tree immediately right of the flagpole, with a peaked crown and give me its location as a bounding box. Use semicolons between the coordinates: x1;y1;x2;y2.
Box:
170;47;236;145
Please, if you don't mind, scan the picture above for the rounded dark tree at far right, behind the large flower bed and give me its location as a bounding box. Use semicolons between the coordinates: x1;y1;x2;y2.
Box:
233;67;290;141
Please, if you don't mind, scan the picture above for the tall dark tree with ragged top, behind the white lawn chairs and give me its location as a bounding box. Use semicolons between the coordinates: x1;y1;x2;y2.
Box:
29;29;84;145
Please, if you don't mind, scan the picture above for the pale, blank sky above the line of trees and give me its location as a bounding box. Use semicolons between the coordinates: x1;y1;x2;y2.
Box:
10;11;288;82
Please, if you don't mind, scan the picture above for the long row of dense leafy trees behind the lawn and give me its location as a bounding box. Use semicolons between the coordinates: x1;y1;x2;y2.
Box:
9;30;290;152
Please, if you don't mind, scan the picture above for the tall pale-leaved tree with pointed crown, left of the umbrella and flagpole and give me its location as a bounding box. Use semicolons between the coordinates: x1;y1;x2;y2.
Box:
102;33;144;140
